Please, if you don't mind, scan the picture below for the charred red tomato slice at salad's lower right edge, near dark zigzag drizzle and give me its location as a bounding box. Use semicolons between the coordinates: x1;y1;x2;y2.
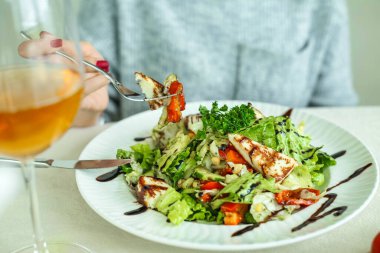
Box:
275;188;320;206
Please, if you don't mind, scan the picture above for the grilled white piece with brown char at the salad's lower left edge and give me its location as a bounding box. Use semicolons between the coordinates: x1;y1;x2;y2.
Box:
136;176;170;209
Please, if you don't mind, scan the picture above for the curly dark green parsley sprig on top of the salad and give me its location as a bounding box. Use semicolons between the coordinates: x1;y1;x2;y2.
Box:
197;101;255;139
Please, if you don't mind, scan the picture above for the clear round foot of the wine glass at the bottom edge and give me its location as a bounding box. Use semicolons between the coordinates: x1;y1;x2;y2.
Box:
12;242;91;253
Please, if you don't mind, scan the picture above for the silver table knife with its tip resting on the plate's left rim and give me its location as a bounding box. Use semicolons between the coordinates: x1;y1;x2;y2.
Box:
0;158;131;170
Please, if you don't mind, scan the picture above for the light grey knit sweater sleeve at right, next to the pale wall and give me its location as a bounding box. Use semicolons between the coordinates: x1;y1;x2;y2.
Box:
310;1;357;106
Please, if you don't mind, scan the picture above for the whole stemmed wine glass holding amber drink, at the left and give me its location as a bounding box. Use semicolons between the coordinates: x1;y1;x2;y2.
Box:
0;0;89;253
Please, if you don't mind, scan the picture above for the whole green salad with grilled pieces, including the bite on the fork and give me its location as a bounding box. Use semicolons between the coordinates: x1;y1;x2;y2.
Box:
116;73;336;225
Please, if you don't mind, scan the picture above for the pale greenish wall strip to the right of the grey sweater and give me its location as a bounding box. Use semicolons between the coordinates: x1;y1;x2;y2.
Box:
346;0;380;105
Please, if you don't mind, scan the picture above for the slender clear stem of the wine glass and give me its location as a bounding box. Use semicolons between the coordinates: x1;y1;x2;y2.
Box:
21;159;49;253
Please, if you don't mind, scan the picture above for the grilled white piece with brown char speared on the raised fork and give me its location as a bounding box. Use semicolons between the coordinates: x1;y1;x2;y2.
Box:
135;72;165;110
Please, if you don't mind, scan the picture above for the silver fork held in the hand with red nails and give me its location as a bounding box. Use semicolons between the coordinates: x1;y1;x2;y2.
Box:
20;31;178;102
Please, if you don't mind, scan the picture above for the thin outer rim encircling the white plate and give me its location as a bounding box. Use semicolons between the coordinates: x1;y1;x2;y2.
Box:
75;100;380;251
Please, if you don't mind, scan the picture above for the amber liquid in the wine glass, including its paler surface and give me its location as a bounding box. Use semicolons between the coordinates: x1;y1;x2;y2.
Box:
0;66;83;158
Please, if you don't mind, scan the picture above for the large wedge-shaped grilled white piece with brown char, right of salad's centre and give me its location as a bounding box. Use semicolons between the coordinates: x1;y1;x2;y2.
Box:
228;134;298;182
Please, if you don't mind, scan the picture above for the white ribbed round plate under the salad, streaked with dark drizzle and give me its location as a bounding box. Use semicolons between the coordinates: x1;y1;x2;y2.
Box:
76;101;378;250
